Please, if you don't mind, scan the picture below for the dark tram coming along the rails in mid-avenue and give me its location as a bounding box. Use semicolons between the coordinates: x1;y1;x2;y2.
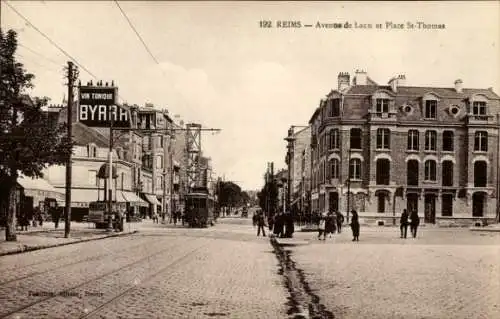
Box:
184;187;214;228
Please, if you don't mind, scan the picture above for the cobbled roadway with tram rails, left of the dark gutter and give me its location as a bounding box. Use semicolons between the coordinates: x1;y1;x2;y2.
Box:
0;220;287;318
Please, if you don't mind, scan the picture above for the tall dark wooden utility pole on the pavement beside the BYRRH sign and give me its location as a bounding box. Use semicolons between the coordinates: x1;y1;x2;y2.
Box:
64;61;75;238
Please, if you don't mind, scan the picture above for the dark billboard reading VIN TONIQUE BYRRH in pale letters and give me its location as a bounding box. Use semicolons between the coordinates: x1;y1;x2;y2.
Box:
78;86;130;128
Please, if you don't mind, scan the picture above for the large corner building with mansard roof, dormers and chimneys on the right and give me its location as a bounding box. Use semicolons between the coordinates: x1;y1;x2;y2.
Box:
309;71;500;223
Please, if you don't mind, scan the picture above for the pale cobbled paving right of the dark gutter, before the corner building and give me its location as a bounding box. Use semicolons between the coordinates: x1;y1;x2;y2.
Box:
285;227;500;319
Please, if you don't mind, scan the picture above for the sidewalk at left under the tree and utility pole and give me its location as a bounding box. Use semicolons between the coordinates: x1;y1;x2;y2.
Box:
0;222;140;256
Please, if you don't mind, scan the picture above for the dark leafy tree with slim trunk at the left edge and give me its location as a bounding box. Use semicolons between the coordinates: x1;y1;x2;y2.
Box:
0;29;73;241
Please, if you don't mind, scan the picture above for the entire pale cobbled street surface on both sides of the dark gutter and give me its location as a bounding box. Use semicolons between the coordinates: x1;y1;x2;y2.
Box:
0;220;500;319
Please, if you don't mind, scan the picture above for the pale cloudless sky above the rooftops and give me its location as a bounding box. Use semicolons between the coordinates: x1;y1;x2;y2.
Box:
1;1;500;189
